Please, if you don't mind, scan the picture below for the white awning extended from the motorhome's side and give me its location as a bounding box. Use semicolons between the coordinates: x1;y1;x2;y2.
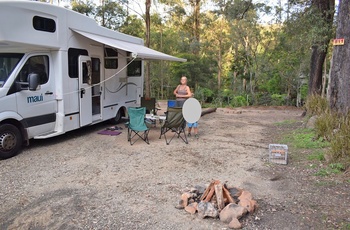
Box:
71;28;187;62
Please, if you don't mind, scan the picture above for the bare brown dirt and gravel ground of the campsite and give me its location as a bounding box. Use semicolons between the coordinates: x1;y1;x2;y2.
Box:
0;104;350;230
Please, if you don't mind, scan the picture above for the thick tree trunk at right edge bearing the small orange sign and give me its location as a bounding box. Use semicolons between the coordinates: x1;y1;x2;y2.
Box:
328;0;350;114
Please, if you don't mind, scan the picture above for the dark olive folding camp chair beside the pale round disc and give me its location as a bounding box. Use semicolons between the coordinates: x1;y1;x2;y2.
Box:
159;108;188;145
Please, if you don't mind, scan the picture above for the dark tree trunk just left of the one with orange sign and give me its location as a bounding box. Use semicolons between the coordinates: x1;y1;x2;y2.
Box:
308;0;335;95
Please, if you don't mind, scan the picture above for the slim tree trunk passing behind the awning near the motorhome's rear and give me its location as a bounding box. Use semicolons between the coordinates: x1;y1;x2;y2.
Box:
145;0;151;97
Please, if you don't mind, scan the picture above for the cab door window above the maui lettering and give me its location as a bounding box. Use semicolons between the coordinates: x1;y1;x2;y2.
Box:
17;55;49;85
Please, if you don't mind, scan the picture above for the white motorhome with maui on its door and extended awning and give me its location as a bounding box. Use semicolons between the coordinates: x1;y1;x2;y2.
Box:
0;1;186;158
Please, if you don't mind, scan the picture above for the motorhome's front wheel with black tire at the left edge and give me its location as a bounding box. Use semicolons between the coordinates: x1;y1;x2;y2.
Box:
0;124;23;159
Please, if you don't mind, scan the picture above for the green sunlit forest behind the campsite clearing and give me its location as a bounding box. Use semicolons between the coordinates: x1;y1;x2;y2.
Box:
58;0;335;106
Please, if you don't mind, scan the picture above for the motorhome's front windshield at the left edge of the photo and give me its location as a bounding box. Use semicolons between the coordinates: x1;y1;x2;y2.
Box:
0;53;24;88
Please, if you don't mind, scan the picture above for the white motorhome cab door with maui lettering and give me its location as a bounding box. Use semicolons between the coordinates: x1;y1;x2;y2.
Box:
13;53;57;138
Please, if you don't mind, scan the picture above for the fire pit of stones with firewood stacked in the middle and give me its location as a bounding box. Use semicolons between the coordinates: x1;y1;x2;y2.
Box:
176;180;258;229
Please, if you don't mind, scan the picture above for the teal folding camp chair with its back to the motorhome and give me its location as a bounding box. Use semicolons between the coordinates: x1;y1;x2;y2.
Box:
126;107;149;145
